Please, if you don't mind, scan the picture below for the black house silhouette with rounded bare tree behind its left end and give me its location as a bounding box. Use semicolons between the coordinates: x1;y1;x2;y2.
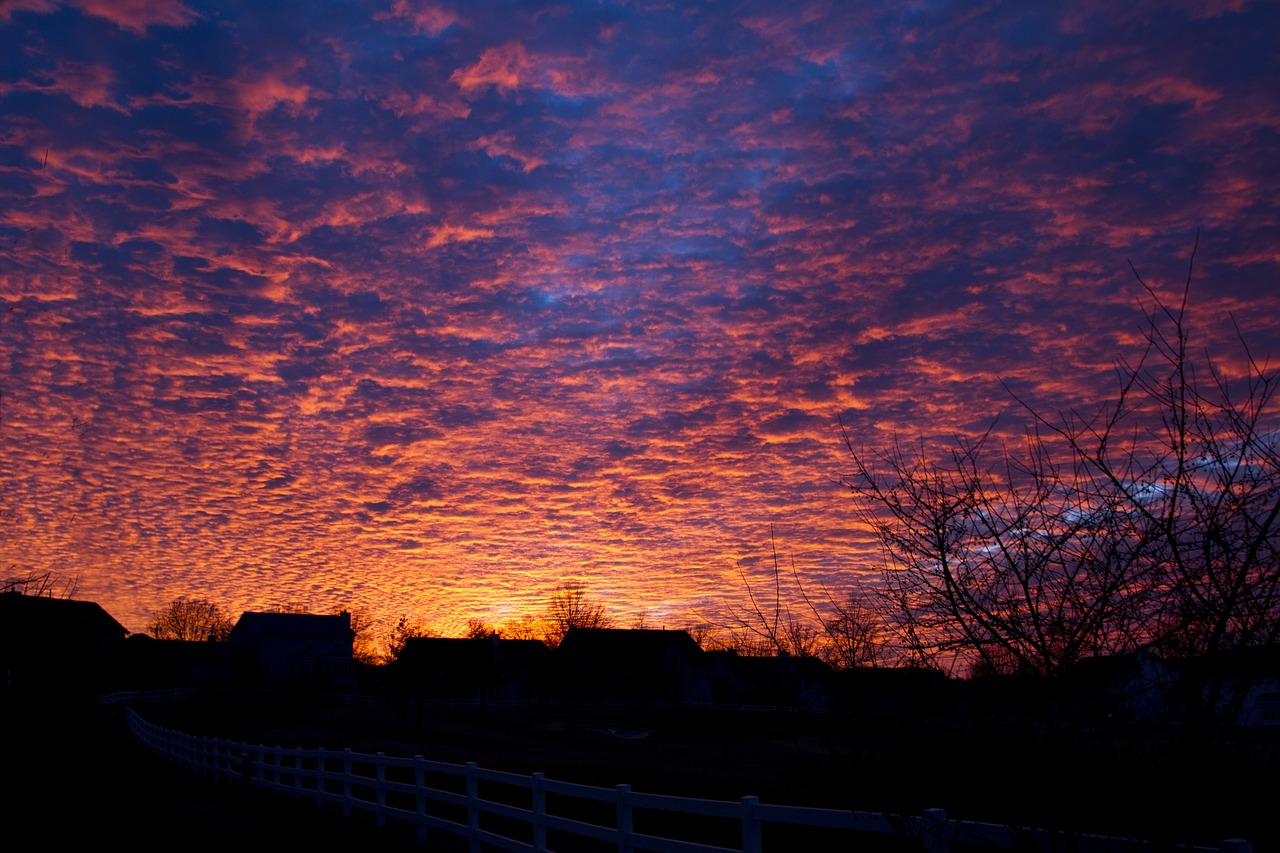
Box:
553;628;710;702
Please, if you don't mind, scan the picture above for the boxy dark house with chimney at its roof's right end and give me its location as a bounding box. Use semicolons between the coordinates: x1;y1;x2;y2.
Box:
228;612;355;689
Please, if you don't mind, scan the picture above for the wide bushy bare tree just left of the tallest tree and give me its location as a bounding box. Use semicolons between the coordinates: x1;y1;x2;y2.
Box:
845;433;1149;675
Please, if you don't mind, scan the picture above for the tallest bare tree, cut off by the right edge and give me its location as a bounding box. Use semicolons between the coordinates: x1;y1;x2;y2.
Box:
1041;252;1280;654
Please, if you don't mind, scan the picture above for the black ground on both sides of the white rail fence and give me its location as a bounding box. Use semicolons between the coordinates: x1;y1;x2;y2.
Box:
3;694;1280;850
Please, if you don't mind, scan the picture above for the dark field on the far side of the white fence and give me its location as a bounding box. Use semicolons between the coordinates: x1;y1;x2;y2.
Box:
135;694;1280;850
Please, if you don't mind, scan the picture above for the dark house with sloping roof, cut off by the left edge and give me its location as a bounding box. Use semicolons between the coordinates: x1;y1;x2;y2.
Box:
0;592;128;695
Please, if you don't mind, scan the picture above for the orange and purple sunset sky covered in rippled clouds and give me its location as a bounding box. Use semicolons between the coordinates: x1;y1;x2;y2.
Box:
0;0;1280;633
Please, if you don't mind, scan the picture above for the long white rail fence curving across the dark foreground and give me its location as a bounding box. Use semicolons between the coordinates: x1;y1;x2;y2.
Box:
125;708;1252;853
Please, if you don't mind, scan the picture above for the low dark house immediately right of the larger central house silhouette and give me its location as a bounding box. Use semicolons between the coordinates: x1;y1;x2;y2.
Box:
707;651;833;711
